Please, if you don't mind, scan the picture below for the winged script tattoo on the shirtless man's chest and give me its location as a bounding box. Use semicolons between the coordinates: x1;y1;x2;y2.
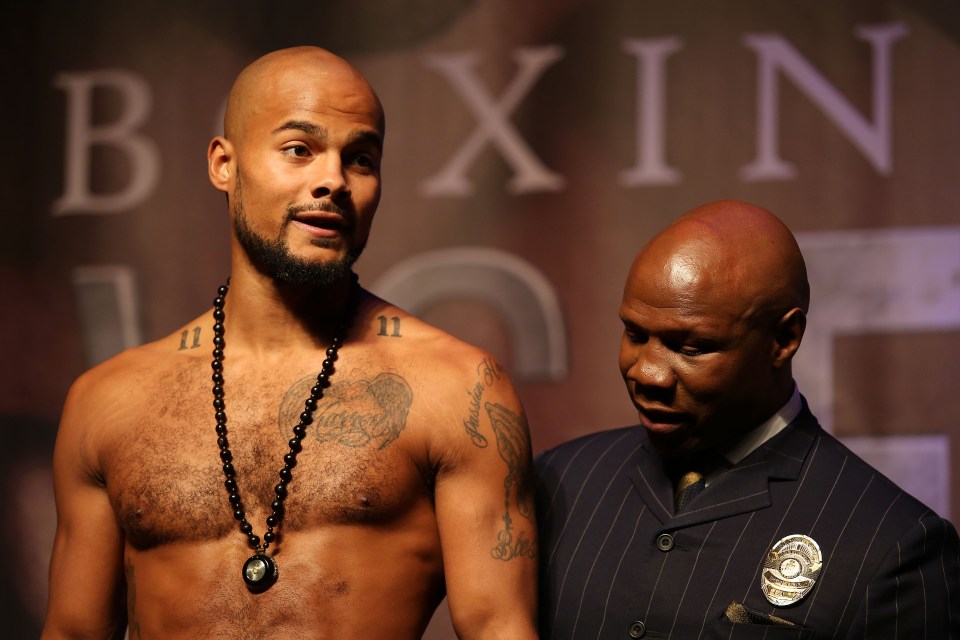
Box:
278;373;413;449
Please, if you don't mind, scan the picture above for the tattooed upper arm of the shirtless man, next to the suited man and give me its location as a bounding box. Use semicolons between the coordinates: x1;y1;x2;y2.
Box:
436;372;537;637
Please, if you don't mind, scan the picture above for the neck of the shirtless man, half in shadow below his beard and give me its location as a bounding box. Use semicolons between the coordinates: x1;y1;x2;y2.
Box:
224;272;354;354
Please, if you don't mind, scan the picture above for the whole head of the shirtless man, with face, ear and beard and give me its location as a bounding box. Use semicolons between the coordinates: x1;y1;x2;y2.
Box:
207;47;384;287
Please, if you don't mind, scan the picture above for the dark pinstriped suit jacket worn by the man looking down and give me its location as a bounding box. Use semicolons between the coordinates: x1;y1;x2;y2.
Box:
537;403;960;640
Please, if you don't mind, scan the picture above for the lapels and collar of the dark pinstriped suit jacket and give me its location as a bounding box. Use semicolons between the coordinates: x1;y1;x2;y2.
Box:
630;403;816;527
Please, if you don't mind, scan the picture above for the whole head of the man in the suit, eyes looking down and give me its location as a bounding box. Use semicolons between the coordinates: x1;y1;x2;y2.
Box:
620;200;809;457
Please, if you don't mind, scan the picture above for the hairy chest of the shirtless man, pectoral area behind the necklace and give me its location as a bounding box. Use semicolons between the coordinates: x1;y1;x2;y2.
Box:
104;360;431;549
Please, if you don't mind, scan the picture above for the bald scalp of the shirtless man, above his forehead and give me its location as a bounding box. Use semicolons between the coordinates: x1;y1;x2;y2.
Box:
223;46;384;141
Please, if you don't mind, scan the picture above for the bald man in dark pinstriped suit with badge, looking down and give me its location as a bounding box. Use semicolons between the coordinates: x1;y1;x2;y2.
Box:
537;201;960;640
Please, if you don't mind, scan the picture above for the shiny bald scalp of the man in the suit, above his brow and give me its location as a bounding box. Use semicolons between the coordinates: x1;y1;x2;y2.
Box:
635;200;810;322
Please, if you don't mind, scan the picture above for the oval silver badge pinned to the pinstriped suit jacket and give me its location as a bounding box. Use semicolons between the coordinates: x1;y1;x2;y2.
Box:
760;534;823;607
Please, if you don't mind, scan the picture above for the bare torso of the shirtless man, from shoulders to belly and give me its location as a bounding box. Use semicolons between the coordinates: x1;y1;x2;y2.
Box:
64;292;533;639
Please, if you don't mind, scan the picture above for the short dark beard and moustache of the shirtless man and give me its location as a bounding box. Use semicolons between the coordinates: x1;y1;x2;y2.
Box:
233;170;364;287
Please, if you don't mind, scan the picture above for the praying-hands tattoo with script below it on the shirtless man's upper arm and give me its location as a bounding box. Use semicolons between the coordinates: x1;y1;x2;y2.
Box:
484;402;537;560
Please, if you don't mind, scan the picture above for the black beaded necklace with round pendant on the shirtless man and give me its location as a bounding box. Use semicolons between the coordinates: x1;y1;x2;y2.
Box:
210;274;359;593
